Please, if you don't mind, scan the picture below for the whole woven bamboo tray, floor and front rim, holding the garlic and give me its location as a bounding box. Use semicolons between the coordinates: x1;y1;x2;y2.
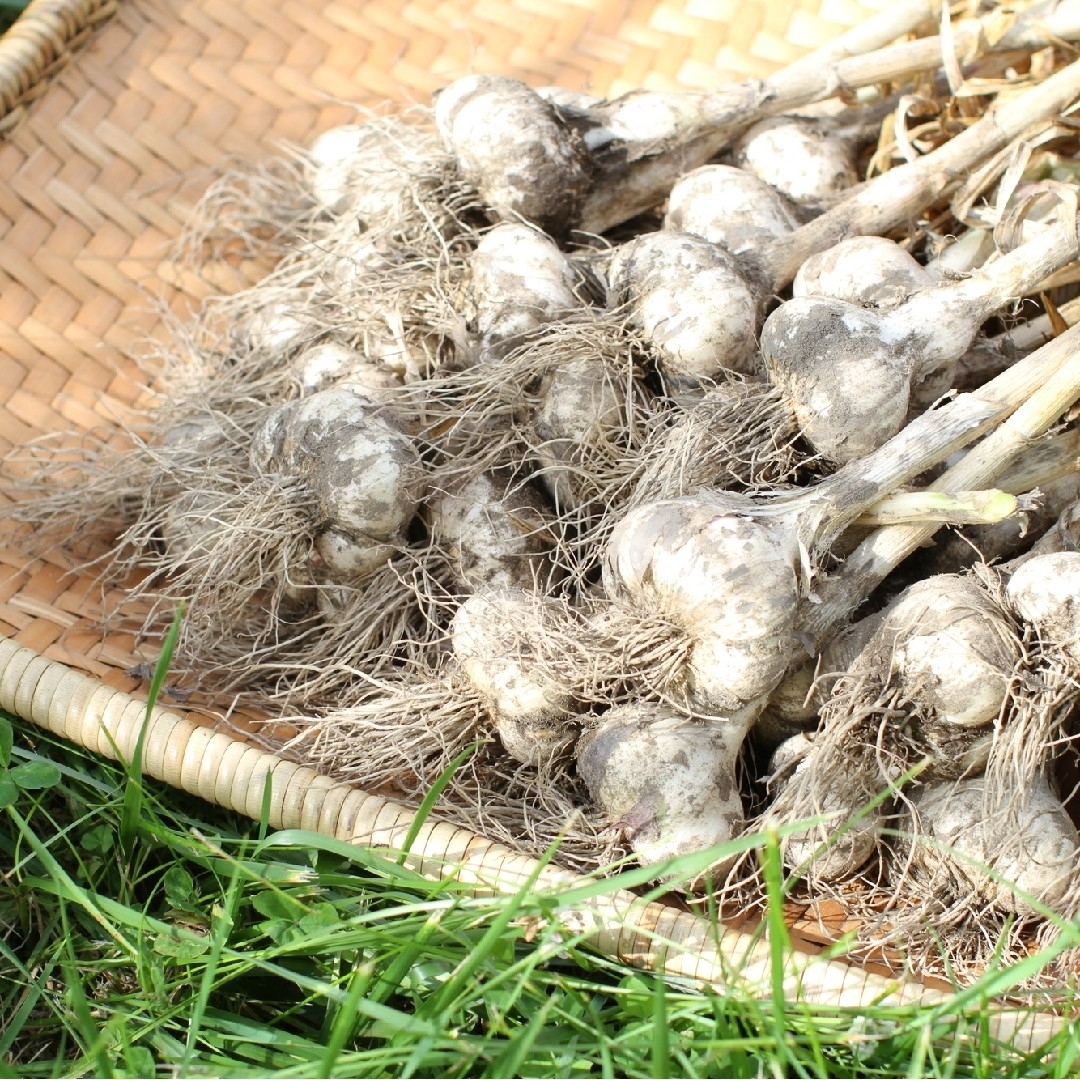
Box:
0;0;1054;1044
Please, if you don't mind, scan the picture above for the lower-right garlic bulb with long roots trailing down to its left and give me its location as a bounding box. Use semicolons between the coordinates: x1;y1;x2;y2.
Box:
764;575;1022;882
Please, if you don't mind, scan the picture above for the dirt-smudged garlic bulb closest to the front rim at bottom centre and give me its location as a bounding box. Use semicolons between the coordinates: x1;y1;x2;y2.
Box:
576;703;758;866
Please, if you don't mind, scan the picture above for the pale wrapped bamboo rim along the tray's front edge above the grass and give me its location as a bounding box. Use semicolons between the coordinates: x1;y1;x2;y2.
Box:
0;638;1064;1051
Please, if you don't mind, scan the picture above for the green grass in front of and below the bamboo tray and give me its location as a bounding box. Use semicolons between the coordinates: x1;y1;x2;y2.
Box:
0;708;1080;1077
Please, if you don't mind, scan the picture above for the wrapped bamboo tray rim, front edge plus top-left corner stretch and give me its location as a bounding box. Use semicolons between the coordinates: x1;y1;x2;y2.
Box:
0;0;1064;1049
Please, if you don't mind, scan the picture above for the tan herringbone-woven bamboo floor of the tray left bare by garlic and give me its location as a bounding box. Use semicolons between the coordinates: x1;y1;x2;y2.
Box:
0;0;874;689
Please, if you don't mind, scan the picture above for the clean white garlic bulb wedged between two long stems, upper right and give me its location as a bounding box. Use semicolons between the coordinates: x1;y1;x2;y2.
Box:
734;117;859;206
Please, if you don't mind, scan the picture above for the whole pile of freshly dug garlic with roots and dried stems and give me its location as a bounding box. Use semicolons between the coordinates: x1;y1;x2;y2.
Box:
8;4;1080;980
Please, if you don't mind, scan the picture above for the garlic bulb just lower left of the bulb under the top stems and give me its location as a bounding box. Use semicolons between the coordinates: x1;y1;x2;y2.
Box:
664;165;799;261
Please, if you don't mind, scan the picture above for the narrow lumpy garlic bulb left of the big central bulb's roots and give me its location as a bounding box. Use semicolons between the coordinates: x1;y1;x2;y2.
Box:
450;589;577;765
